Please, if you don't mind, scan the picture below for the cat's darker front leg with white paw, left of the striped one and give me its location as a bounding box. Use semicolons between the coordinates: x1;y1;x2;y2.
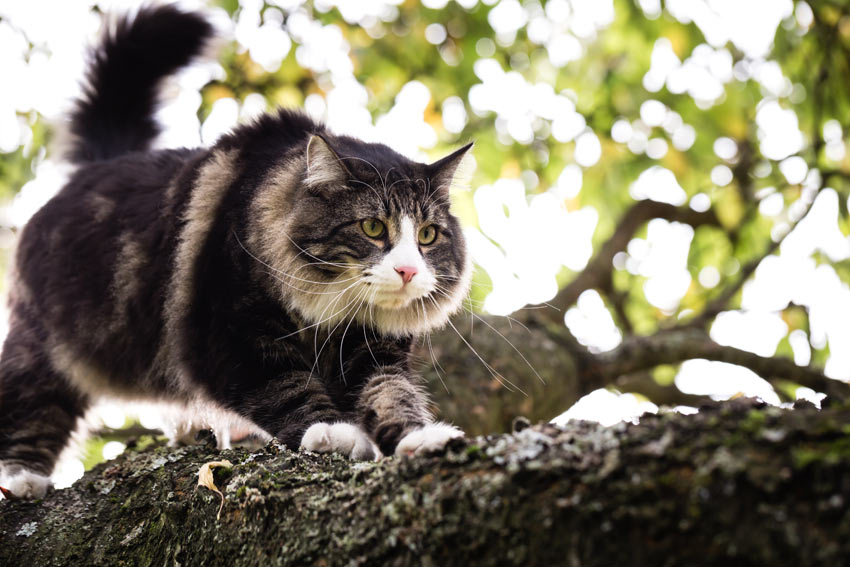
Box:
232;372;377;460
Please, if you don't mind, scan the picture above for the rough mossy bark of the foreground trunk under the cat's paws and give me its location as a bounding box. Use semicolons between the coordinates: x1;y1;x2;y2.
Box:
0;401;850;567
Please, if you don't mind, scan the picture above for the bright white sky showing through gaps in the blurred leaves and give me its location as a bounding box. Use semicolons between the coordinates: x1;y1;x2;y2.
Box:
0;0;850;485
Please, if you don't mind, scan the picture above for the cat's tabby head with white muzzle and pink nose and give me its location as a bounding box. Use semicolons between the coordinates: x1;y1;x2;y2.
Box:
252;136;472;336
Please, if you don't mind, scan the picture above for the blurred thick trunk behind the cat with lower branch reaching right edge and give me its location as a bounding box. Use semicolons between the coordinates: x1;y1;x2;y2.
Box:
414;306;850;435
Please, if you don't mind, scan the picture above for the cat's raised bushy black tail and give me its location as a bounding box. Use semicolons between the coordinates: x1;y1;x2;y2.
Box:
66;5;214;163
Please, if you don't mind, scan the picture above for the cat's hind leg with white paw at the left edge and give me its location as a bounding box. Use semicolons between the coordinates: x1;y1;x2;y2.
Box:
0;324;88;498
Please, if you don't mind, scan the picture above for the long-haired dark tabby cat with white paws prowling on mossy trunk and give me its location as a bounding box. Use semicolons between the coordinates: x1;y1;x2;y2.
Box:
0;5;471;498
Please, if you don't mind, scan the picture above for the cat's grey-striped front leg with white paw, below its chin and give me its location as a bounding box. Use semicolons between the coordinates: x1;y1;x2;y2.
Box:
358;372;463;455
